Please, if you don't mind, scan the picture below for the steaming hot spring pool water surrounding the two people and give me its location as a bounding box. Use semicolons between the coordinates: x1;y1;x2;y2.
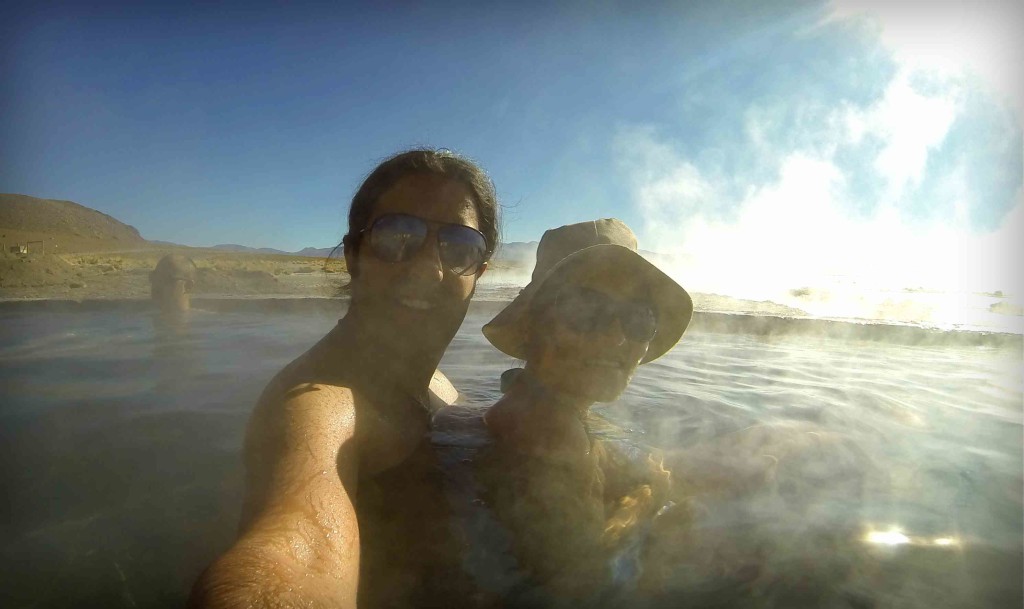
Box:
0;294;1024;608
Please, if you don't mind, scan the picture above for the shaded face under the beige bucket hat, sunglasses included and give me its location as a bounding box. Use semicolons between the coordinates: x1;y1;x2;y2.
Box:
527;269;655;403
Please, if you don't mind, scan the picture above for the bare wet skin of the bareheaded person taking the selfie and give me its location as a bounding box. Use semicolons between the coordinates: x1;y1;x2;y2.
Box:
190;175;485;607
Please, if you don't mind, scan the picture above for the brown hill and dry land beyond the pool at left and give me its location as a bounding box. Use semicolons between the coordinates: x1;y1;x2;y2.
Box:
0;194;356;301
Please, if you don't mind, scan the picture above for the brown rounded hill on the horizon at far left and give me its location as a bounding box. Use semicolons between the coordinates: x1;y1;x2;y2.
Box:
0;194;144;246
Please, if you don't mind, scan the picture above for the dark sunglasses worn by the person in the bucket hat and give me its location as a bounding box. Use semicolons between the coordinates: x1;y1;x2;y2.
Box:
554;288;657;342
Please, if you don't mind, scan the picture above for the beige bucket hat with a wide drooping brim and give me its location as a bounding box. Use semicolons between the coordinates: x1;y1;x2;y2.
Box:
483;218;693;363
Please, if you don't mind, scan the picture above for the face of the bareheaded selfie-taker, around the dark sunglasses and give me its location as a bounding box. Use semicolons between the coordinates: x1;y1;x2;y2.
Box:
348;174;483;346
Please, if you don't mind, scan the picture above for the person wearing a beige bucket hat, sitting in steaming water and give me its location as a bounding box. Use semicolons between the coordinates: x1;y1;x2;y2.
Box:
481;219;693;606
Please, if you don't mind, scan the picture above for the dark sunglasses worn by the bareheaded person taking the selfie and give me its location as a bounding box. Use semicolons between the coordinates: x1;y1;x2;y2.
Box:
359;214;487;275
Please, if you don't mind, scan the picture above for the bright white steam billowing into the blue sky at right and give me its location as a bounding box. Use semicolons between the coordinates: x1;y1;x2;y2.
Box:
615;2;1024;333
